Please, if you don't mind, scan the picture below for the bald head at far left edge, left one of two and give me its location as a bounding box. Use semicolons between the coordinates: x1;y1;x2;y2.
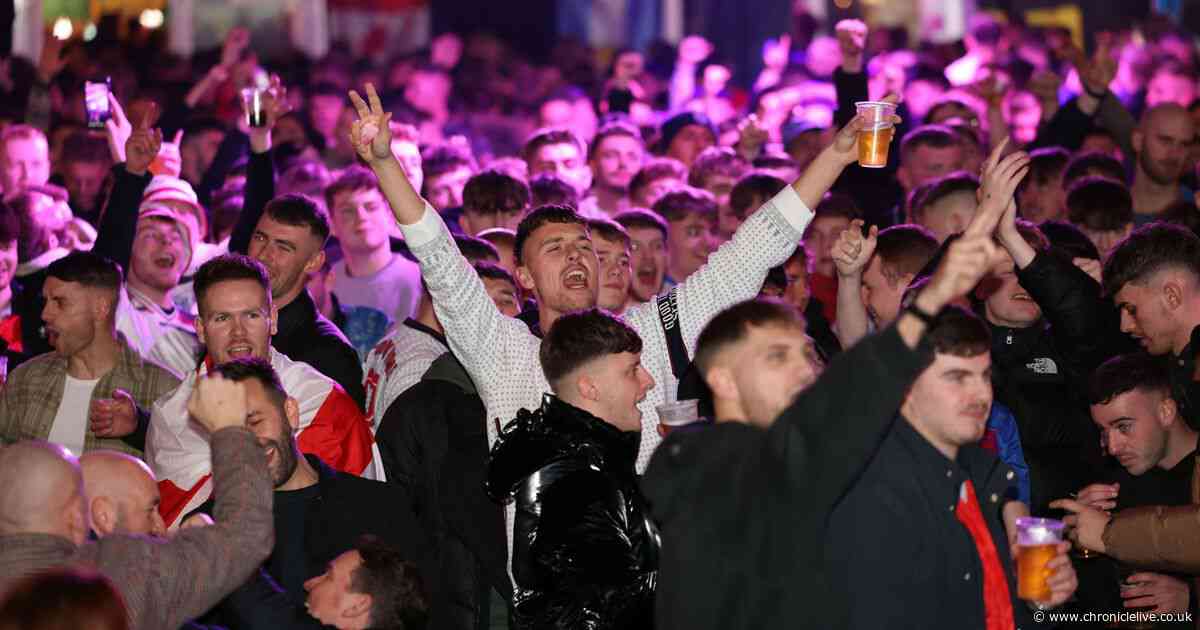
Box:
0;442;88;545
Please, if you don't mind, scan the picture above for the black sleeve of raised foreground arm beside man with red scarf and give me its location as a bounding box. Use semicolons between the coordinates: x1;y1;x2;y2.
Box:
770;324;932;510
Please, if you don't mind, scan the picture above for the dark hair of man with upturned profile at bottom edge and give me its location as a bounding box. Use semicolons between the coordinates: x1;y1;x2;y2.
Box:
350;535;430;630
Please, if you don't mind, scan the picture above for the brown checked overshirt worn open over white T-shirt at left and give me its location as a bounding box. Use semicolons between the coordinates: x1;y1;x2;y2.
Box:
0;334;179;457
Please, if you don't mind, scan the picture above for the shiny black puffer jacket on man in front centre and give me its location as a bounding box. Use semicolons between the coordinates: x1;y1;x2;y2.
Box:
487;395;659;630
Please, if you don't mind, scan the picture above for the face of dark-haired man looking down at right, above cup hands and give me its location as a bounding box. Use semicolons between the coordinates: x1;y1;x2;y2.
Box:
1091;389;1171;476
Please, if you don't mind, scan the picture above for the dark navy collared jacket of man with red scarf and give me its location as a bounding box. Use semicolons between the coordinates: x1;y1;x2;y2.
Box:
827;419;1028;630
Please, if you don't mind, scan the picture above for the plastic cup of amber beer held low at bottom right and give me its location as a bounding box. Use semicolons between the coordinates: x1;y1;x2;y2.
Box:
1015;516;1079;608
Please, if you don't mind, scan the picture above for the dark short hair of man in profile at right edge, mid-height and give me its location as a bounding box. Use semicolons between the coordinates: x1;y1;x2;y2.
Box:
1104;222;1200;295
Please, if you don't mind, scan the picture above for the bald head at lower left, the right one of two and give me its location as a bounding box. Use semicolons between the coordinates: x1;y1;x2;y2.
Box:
79;451;164;538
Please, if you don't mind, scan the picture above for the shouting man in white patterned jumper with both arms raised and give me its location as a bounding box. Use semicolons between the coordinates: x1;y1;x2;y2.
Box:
350;84;894;561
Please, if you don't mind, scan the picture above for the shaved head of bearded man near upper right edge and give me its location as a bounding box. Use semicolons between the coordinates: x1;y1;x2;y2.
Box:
1133;103;1195;186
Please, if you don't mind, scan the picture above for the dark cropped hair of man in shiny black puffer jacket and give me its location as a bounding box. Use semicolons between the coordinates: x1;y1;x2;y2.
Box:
538;308;642;391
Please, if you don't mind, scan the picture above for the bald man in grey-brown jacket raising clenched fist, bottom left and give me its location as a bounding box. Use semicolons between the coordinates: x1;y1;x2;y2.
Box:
0;377;274;629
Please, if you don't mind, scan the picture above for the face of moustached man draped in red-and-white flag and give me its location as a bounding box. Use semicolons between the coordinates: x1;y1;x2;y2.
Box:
196;280;275;364
